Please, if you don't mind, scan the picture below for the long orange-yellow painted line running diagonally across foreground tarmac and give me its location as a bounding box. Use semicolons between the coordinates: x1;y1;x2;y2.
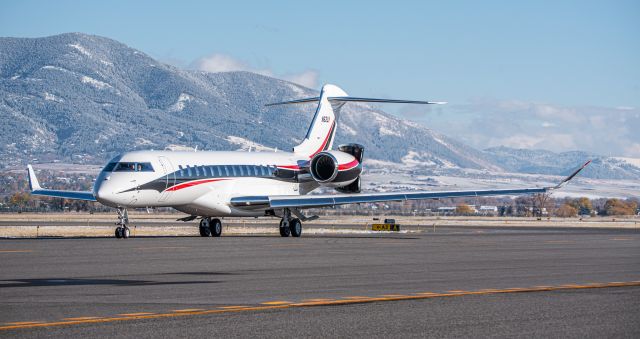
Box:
5;281;640;330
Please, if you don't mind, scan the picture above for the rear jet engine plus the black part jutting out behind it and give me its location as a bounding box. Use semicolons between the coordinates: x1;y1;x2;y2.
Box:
309;144;364;193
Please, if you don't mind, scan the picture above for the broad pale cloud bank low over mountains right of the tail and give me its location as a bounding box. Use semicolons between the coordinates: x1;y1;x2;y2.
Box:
408;100;640;157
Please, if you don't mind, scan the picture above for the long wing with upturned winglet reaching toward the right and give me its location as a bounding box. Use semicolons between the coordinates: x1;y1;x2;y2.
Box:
231;161;591;209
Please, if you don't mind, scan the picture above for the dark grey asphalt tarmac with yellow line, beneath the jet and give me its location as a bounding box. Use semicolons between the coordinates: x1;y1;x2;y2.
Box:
0;227;640;338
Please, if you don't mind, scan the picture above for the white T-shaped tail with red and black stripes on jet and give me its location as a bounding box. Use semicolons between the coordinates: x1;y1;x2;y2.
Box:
266;84;446;158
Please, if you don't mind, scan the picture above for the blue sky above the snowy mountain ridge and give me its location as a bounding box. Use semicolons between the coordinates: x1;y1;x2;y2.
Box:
0;1;640;157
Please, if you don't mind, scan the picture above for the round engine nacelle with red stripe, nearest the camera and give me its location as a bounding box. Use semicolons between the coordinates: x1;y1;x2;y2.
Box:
309;150;362;188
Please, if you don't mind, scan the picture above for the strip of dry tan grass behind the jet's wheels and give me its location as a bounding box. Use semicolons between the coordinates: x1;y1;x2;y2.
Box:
0;212;640;238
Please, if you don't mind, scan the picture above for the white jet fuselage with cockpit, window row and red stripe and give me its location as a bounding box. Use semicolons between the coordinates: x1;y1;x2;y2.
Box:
94;151;319;216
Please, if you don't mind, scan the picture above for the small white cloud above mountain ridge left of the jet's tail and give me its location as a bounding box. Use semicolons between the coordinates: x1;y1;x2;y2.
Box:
192;53;318;88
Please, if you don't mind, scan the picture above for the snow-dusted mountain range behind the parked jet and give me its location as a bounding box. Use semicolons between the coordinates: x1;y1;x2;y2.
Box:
0;33;640;179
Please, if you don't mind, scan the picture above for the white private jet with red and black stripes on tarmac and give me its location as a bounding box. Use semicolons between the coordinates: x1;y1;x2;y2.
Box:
27;84;590;239
